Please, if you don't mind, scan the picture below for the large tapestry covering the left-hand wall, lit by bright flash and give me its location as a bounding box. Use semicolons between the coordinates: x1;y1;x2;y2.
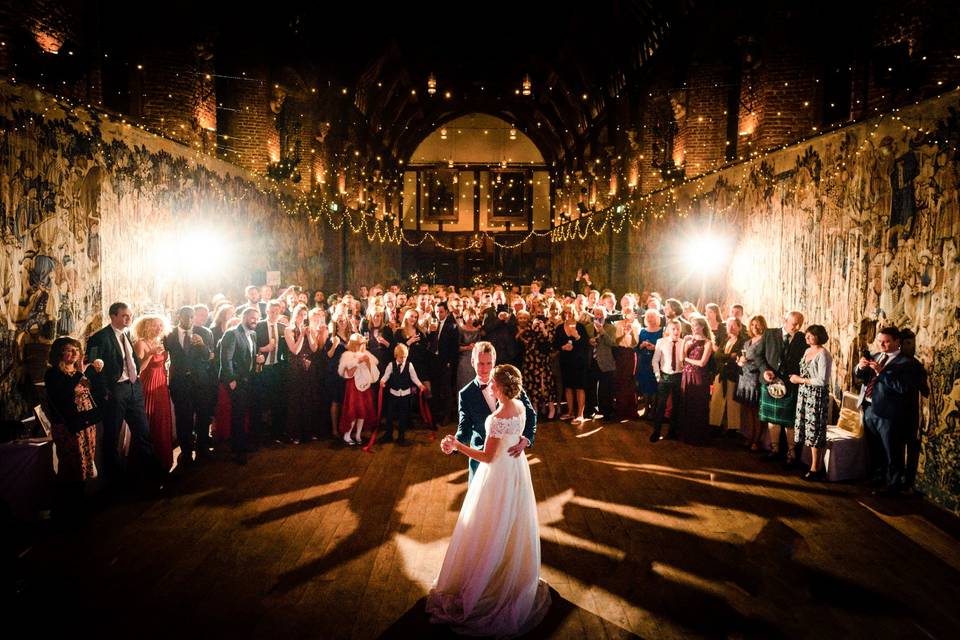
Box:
0;83;328;419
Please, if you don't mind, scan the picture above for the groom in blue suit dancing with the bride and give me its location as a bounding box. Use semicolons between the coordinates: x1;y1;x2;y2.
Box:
441;342;537;481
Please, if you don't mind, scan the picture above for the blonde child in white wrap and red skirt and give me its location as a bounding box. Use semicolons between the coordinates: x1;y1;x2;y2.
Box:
337;333;380;445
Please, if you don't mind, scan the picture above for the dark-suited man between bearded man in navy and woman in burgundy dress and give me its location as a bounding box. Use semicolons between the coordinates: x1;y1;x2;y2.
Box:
254;300;289;444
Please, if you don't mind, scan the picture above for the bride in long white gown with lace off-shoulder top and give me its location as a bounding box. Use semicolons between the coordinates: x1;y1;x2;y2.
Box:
427;365;550;637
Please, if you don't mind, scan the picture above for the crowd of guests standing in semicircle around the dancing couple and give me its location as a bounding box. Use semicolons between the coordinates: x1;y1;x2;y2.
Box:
39;272;927;524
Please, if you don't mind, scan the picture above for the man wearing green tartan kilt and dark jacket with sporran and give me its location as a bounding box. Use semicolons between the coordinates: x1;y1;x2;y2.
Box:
758;311;807;465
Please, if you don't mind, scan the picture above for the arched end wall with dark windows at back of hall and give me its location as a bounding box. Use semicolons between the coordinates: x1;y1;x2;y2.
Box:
401;113;553;286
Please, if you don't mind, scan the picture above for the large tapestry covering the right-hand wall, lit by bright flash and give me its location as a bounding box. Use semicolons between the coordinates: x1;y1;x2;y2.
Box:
553;91;960;511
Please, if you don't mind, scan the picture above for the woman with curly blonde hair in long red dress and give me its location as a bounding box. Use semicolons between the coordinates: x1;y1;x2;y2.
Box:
133;315;173;470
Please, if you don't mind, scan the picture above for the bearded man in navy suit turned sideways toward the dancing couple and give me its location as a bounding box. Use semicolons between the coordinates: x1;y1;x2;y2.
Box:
220;307;266;464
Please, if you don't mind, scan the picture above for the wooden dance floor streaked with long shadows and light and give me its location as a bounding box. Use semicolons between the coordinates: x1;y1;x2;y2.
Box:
13;422;960;639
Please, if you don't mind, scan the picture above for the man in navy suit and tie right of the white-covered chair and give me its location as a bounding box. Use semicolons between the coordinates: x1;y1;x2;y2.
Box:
854;327;921;495
